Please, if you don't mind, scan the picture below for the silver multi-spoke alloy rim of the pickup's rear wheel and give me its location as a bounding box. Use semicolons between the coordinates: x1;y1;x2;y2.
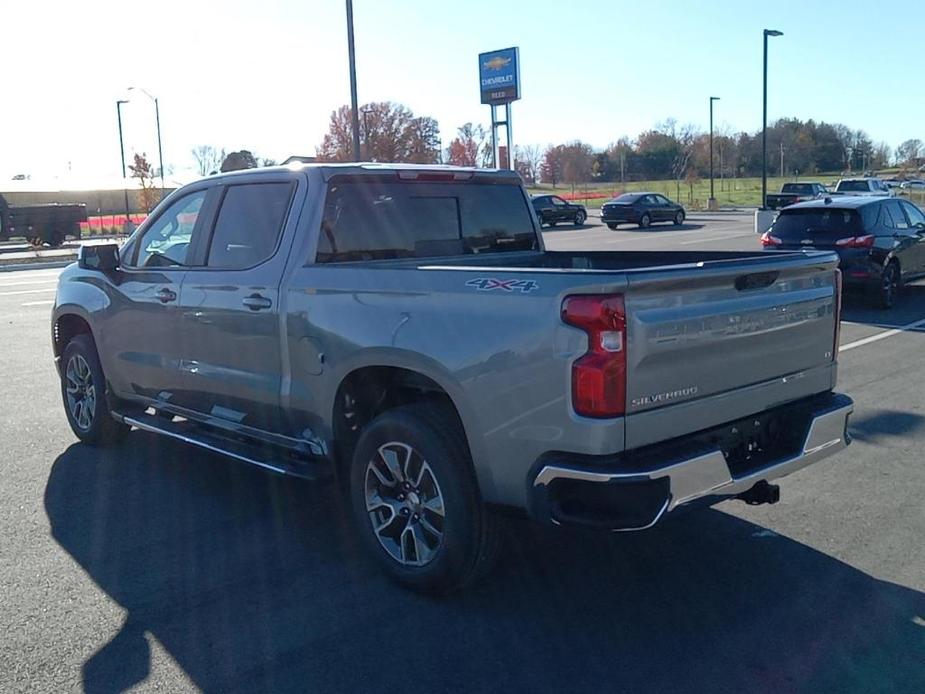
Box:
365;441;446;567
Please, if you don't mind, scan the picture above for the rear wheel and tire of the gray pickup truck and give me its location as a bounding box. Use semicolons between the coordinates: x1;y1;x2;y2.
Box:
350;404;499;594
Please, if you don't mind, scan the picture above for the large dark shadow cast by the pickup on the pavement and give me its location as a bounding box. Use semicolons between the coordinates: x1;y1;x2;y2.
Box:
45;440;925;694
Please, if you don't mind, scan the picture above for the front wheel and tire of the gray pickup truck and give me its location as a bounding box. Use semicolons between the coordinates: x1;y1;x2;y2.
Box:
61;335;130;446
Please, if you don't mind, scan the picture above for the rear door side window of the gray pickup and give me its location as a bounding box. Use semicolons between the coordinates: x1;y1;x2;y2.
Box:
206;183;293;270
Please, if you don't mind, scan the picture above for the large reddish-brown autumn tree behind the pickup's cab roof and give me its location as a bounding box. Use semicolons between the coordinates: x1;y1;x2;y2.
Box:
316;101;440;164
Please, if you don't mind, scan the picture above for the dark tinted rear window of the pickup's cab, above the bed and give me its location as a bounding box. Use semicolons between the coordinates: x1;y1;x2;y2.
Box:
316;180;537;263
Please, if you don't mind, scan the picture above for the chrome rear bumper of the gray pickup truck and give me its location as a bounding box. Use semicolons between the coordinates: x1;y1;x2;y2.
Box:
533;395;854;531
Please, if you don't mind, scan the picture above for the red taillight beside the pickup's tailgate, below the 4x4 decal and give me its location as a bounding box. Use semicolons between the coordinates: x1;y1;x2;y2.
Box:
562;294;626;417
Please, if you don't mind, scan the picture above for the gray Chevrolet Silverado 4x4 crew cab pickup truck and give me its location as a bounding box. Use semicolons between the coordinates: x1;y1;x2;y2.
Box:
52;165;852;591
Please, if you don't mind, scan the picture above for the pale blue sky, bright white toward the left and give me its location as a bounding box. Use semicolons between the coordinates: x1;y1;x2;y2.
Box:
0;0;925;179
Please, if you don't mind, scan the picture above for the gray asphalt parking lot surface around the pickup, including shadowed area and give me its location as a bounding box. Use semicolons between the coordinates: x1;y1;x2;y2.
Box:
0;213;925;694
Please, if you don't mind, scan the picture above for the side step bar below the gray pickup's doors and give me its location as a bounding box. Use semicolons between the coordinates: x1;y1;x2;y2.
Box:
112;412;334;480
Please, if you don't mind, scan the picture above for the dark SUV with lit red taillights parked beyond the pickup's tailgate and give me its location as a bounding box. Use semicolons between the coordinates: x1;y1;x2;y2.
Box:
761;197;925;308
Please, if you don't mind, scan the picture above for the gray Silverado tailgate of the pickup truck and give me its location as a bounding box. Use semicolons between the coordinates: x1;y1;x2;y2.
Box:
625;253;838;447
